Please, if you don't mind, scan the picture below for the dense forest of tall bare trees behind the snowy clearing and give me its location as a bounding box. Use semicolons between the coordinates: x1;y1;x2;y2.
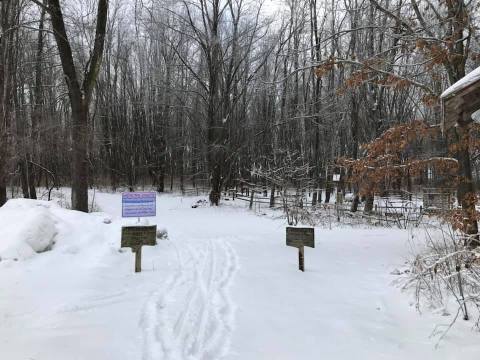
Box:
0;0;480;211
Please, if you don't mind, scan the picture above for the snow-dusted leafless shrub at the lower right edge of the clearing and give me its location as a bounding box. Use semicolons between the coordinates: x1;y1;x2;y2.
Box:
405;225;480;330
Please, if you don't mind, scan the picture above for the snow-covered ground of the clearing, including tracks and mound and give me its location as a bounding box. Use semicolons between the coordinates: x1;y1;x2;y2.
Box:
0;193;480;360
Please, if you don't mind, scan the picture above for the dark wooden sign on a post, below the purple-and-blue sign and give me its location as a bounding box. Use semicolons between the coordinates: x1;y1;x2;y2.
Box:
121;225;157;272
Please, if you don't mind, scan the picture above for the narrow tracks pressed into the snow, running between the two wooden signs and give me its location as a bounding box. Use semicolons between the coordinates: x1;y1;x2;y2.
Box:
141;239;237;360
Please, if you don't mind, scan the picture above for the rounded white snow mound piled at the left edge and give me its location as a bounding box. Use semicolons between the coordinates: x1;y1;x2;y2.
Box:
0;199;57;260
